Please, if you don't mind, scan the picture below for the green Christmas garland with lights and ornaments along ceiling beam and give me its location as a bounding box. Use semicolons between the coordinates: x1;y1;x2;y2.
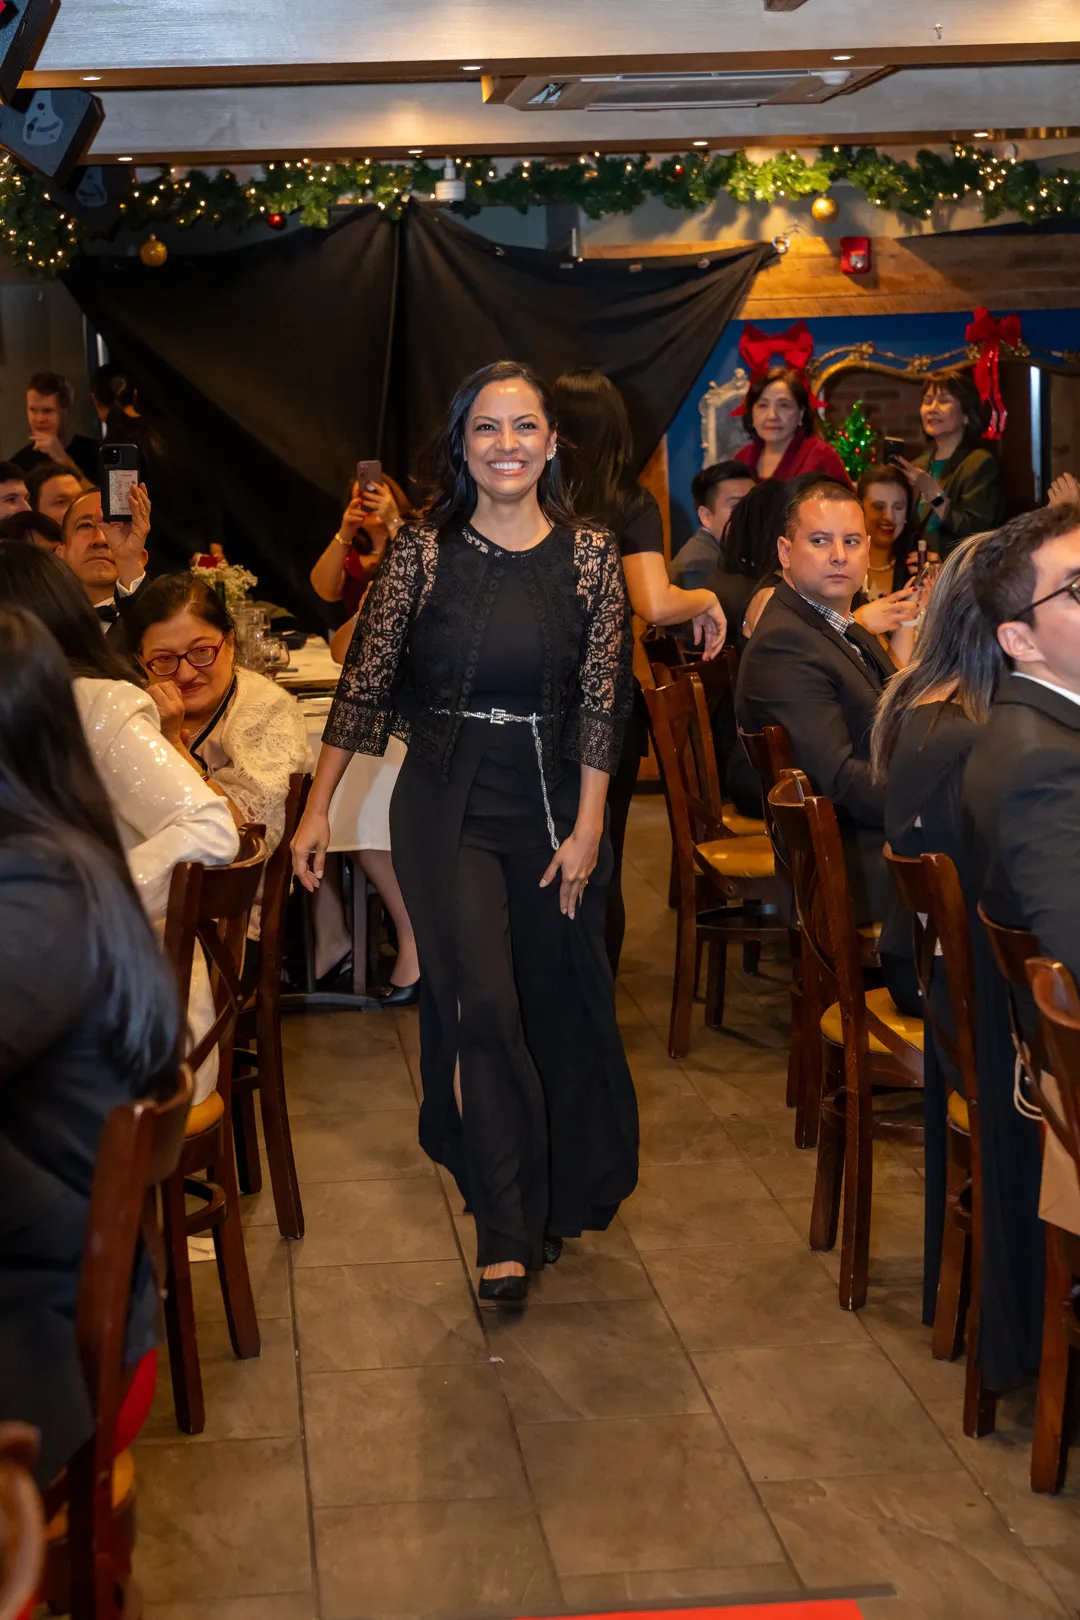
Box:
8;146;1080;274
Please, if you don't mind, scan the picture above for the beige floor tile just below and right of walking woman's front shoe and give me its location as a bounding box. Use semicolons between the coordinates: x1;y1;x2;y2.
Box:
487;1299;709;1424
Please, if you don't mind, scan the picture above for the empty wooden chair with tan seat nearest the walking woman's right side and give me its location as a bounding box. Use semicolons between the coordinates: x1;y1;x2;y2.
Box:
644;672;785;1058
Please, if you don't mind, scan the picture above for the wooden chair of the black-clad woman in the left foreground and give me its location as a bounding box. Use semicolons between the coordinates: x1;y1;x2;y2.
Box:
40;1066;191;1620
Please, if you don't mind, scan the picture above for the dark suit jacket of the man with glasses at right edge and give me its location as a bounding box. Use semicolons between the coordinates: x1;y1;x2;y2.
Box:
963;674;1080;982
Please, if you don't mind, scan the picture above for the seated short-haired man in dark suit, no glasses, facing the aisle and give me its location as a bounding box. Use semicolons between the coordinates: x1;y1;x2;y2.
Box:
735;478;895;923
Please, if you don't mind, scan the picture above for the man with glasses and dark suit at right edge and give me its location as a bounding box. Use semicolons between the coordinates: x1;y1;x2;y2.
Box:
963;505;1080;982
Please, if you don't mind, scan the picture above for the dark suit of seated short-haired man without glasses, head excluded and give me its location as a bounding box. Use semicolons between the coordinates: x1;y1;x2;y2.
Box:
735;580;895;923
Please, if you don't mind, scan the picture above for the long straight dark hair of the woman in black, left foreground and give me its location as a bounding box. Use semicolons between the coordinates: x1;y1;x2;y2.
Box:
0;609;180;1097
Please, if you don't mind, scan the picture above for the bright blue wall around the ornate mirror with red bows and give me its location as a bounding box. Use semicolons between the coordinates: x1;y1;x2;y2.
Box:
667;309;1080;551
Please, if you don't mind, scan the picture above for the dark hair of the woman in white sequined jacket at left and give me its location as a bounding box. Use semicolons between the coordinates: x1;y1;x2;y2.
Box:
0;539;139;685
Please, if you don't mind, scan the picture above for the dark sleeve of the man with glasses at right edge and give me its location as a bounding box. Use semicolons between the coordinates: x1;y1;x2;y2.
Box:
997;745;1080;982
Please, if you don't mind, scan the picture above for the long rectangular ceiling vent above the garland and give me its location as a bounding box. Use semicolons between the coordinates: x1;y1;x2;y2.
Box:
484;65;887;112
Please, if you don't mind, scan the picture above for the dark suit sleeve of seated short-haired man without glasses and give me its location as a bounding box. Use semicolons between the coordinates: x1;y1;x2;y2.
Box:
740;622;886;828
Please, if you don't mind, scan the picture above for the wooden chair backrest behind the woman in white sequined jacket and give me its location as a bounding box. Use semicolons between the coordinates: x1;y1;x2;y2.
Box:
165;826;266;1100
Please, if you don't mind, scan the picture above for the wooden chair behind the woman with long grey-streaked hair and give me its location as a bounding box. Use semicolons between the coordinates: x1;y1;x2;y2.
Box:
886;844;997;1439
